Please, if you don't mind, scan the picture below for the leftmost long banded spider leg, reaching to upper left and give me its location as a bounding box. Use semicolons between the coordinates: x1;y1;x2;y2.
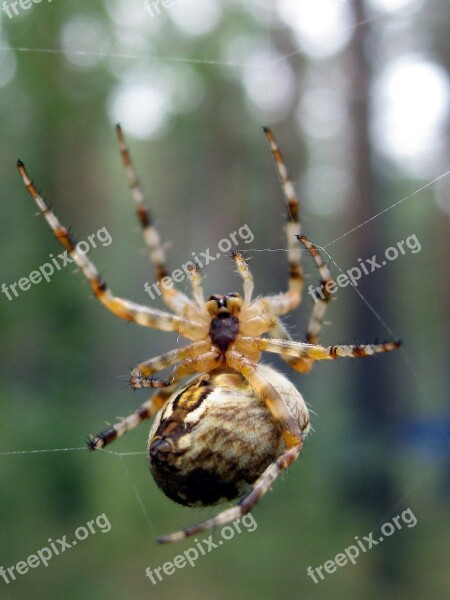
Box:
17;160;197;339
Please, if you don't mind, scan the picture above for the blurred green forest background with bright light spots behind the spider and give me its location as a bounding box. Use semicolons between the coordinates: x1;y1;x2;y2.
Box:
0;0;450;600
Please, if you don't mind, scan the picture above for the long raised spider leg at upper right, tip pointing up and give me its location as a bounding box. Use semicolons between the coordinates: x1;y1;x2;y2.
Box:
264;127;303;315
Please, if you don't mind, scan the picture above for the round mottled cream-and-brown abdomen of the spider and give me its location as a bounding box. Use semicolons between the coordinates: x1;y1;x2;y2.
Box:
148;366;309;506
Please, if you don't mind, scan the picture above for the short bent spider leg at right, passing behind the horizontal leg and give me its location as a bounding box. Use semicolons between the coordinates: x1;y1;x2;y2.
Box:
269;235;333;373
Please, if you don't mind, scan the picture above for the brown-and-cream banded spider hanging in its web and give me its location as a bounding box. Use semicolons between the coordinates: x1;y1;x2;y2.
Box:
18;125;399;542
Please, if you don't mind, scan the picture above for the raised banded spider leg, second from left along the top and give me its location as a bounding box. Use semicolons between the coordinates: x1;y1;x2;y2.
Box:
116;125;191;313
